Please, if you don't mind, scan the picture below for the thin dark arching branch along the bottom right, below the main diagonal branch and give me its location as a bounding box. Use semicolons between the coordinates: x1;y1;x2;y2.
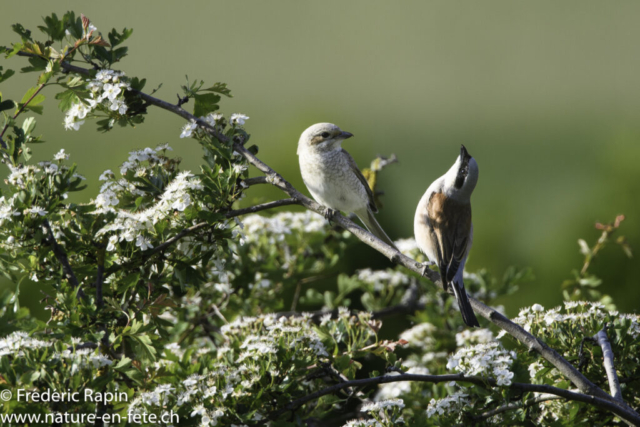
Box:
269;374;640;425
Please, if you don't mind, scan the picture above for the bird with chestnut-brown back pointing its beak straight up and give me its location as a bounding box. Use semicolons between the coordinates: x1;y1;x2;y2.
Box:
413;145;480;327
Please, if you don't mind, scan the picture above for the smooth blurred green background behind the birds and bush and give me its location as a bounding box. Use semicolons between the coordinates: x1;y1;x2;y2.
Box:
0;0;640;318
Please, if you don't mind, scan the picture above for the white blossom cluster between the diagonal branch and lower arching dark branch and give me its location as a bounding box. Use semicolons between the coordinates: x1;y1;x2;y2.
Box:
447;341;516;386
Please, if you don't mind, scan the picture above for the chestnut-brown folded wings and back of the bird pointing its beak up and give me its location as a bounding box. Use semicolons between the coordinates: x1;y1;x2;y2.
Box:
428;193;471;283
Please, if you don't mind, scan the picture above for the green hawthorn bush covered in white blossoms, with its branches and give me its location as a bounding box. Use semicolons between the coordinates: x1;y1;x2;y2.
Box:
0;12;640;427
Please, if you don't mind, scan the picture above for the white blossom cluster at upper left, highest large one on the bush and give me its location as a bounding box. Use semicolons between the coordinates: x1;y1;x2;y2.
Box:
64;70;131;130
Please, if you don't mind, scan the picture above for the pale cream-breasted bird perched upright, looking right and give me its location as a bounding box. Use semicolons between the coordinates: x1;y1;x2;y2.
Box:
297;123;395;248
